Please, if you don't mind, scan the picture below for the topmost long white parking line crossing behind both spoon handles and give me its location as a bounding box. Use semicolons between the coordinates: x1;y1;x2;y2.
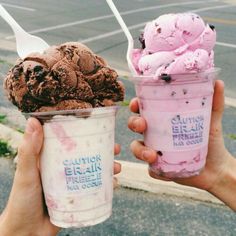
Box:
5;0;221;39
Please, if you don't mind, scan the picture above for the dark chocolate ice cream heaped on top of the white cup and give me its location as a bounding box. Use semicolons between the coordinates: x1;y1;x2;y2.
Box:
4;42;124;112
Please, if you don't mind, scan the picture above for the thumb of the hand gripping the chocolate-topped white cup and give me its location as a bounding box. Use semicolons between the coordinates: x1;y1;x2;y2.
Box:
17;118;43;173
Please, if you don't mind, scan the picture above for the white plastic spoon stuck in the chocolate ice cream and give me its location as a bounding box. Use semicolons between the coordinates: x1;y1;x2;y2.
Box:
0;5;49;58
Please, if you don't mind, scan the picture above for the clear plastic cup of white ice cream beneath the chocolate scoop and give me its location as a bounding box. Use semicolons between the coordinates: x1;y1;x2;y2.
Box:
27;106;117;228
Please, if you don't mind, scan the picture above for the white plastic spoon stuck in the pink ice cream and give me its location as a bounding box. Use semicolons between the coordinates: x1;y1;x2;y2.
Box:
106;0;137;75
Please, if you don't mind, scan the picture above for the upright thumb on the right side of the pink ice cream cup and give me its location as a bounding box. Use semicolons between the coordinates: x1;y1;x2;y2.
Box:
211;80;224;136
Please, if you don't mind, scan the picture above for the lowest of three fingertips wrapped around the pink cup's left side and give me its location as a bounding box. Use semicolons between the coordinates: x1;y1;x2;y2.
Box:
130;140;157;164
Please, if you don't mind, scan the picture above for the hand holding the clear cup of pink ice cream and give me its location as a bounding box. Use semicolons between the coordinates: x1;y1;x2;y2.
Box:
128;80;235;192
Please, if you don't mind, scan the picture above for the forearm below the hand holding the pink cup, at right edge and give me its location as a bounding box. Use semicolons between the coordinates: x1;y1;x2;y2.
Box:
209;154;236;211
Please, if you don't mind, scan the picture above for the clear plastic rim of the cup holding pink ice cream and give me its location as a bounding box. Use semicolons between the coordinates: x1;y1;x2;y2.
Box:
131;67;221;85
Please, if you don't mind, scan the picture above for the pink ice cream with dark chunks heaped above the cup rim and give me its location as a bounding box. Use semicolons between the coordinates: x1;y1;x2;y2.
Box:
133;13;216;76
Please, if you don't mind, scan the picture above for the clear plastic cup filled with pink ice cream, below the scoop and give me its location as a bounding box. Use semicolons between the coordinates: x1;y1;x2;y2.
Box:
132;68;220;178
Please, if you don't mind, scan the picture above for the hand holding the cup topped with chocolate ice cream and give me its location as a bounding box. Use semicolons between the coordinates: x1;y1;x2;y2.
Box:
0;118;121;236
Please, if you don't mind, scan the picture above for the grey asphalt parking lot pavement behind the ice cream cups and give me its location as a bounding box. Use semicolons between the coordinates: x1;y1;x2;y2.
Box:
0;0;236;236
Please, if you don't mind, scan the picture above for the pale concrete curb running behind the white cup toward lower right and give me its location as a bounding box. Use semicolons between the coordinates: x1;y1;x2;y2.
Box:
0;124;224;205
